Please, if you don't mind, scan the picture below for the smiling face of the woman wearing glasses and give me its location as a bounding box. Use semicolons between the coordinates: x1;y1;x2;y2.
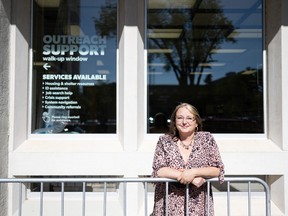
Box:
175;106;198;135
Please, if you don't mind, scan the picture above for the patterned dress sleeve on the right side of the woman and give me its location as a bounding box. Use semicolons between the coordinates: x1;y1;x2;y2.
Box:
208;133;225;184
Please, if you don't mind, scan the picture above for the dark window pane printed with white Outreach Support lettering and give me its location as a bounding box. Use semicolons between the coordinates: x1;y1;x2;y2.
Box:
32;0;117;134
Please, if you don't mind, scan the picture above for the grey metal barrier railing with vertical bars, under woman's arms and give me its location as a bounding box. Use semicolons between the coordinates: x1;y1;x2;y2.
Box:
0;177;271;216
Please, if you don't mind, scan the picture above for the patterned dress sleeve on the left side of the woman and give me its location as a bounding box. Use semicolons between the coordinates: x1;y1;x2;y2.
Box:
152;136;167;178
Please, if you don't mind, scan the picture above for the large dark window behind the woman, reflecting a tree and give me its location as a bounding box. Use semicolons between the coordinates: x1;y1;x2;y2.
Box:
146;0;264;133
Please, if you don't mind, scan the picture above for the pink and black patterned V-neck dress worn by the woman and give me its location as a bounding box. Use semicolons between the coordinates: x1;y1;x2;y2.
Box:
151;132;224;216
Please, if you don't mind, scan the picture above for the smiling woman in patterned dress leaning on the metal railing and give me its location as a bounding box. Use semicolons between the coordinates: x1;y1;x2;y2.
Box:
152;103;224;216
